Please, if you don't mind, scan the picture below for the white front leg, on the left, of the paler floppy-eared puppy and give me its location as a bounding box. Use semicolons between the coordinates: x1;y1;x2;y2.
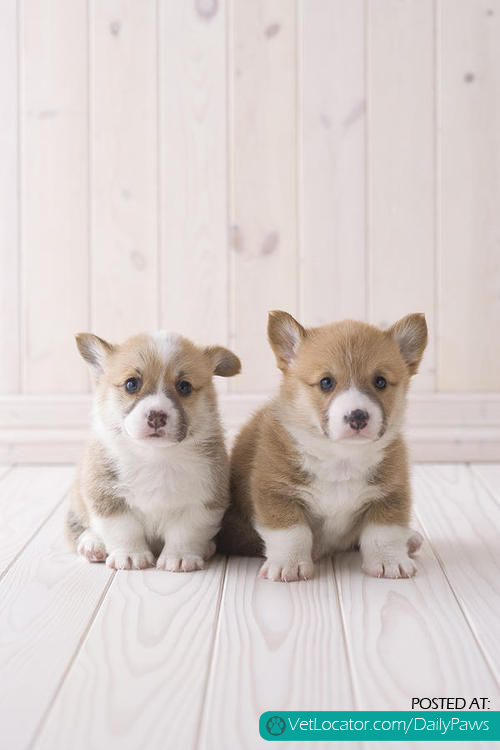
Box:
92;516;154;570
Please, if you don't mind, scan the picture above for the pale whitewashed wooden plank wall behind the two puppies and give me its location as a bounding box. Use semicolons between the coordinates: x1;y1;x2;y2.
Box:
0;0;500;459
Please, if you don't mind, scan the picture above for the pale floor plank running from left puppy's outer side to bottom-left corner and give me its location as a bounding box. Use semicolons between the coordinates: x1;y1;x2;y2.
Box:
0;502;113;750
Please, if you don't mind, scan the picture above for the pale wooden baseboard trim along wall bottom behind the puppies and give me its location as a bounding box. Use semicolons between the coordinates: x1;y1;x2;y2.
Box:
0;393;500;463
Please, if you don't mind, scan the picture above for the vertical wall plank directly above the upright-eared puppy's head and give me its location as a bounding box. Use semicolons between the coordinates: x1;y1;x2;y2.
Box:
298;0;367;325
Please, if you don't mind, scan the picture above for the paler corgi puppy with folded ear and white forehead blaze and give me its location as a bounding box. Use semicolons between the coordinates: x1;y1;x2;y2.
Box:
66;332;240;571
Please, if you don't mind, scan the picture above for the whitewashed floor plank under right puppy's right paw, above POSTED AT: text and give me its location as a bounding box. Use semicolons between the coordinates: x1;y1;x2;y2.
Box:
335;516;498;711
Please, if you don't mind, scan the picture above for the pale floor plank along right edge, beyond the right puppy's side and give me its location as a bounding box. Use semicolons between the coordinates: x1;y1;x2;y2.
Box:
415;465;500;692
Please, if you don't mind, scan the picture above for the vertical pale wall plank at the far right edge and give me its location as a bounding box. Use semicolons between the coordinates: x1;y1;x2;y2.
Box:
438;0;500;391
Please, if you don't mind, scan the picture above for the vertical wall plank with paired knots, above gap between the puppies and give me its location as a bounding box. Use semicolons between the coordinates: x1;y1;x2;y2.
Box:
229;0;298;391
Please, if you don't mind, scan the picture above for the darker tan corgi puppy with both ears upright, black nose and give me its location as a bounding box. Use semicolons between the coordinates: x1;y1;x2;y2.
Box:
218;312;427;581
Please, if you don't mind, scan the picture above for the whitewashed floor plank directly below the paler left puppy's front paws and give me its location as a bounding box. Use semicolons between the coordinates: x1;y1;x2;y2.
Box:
35;558;225;750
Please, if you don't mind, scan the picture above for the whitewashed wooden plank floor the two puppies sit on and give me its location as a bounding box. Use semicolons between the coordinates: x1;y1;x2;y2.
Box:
0;465;500;750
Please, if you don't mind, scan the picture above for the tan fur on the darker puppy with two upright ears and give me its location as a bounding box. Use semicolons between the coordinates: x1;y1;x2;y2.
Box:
219;312;427;576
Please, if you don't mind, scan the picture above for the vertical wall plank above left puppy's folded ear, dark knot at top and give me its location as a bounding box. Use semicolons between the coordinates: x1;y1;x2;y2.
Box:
159;0;228;352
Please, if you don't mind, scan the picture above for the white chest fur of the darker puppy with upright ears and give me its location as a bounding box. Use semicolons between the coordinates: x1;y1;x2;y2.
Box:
306;462;376;552
